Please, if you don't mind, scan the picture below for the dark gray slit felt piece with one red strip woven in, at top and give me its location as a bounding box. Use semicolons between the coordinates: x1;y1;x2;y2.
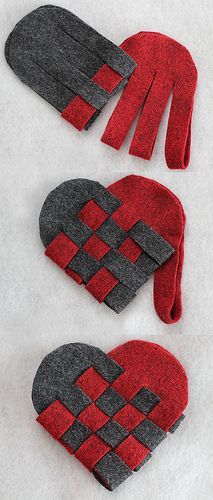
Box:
5;5;136;128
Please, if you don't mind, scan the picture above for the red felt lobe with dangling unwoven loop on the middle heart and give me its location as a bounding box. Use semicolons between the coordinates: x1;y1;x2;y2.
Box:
108;175;185;323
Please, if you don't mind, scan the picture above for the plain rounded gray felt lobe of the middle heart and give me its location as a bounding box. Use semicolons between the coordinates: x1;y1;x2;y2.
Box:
39;179;122;247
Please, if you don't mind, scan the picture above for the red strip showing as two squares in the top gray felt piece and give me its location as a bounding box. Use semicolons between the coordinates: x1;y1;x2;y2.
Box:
61;64;123;131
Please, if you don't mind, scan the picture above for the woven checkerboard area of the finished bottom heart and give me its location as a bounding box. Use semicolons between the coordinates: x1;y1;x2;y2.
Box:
37;360;183;490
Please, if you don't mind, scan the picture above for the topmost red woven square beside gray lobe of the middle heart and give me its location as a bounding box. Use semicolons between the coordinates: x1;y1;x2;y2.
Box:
78;200;108;231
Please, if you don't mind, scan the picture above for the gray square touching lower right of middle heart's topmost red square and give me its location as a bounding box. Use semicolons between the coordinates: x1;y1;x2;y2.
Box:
96;219;127;249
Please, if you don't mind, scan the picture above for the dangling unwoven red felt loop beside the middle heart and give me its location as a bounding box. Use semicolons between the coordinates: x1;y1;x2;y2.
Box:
154;235;184;324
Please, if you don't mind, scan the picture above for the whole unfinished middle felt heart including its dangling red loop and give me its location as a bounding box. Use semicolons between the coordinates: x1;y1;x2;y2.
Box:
39;175;185;323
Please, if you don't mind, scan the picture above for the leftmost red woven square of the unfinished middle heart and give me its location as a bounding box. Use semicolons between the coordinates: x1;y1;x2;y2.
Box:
45;233;79;269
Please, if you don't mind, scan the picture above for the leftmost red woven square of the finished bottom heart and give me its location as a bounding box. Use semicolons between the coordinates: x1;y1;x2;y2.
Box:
36;400;75;440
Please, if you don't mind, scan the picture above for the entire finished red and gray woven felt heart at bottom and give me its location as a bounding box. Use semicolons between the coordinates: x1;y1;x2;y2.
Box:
32;340;188;491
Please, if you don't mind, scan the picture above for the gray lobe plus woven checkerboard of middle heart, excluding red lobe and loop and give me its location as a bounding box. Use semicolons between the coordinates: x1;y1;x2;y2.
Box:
40;179;175;313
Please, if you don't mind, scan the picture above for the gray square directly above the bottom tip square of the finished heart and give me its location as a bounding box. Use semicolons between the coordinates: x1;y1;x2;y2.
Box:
96;420;129;448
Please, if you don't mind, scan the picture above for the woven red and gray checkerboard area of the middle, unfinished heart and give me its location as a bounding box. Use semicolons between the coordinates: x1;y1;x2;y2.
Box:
45;187;174;313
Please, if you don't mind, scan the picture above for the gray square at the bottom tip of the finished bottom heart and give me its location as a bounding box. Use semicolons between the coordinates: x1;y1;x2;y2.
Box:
93;451;132;491
